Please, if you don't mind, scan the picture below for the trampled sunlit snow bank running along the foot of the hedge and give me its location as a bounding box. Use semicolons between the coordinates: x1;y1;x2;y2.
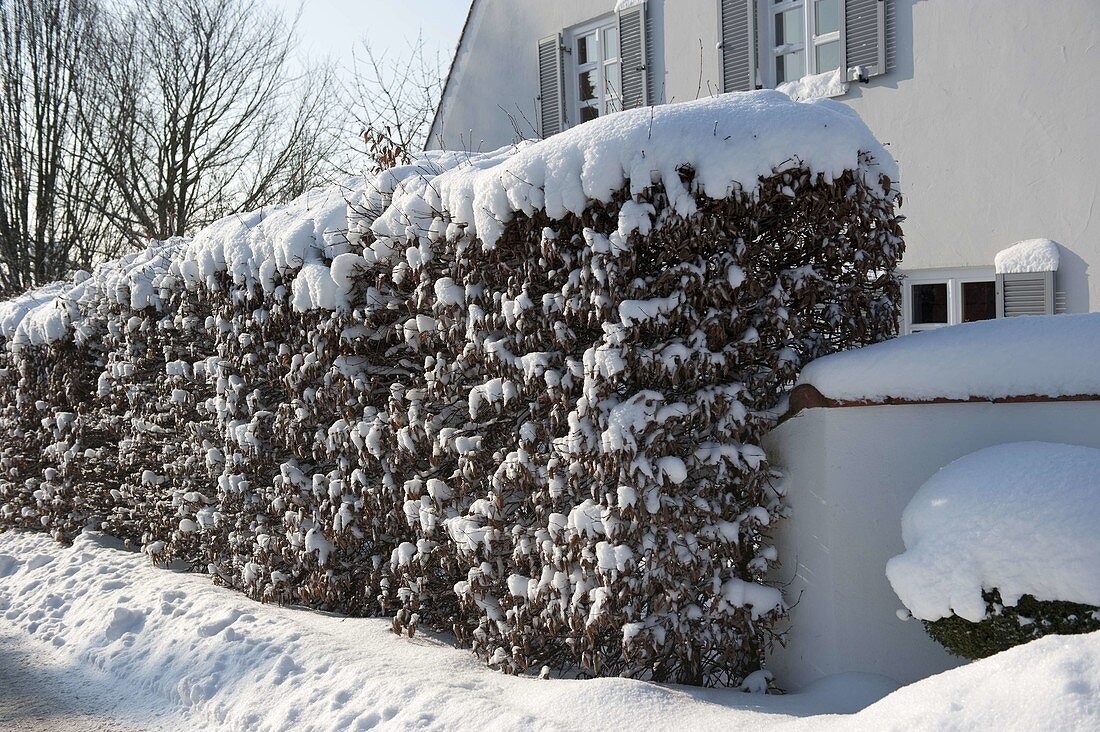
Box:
0;532;891;731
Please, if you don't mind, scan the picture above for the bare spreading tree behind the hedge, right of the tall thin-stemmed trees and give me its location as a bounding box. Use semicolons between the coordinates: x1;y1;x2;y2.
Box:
80;0;336;240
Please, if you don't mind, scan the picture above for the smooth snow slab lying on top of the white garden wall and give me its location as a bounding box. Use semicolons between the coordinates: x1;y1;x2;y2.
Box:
799;313;1100;402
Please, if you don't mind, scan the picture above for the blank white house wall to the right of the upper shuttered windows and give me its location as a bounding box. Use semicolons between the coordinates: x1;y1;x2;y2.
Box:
842;0;1100;313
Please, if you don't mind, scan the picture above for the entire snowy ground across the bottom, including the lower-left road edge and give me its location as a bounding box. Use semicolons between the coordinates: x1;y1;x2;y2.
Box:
0;533;1100;731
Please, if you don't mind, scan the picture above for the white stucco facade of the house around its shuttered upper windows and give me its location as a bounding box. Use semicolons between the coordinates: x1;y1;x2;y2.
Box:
429;0;1100;313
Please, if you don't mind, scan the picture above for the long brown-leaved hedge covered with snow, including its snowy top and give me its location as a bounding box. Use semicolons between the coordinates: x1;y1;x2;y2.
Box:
0;92;902;684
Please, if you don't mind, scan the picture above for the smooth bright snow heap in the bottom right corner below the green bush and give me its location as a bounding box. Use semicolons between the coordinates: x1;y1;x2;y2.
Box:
805;633;1100;732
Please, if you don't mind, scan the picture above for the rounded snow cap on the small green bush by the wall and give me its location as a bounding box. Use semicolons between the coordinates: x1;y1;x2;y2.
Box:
887;443;1100;622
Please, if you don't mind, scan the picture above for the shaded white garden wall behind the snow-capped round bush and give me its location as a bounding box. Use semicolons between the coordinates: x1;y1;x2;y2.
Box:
765;401;1100;689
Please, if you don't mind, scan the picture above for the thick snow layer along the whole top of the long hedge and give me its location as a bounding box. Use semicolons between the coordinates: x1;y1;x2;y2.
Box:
0;90;898;345
